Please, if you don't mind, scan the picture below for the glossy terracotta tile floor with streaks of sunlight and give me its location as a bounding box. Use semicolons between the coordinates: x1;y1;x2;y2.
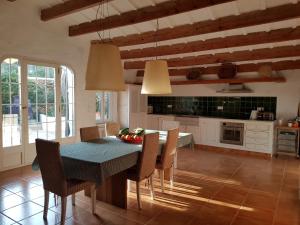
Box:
0;150;300;225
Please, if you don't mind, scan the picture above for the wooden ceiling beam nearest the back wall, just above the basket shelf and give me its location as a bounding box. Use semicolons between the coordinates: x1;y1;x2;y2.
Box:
136;60;300;77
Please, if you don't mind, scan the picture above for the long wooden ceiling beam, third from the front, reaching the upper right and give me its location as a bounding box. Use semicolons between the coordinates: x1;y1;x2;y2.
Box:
95;2;300;46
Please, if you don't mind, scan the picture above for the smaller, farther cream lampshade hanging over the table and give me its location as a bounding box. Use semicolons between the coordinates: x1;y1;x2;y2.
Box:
141;60;172;95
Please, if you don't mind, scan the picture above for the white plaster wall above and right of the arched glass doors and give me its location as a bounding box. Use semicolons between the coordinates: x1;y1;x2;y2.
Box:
0;0;96;140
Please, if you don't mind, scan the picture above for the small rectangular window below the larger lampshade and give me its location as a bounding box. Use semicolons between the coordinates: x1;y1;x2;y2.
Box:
96;92;112;122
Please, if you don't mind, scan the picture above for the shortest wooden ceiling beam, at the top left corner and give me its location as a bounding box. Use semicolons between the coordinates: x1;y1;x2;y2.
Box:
41;0;111;21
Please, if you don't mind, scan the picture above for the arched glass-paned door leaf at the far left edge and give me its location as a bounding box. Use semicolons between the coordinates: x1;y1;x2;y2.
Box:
0;58;24;168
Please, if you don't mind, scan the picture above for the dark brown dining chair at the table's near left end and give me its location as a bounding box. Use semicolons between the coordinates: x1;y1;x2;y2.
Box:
35;139;96;225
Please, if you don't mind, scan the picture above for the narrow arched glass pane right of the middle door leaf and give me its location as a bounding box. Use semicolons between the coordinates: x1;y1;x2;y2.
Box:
60;66;75;138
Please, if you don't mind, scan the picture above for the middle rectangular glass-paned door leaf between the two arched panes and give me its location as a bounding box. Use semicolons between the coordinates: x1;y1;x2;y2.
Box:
25;63;60;162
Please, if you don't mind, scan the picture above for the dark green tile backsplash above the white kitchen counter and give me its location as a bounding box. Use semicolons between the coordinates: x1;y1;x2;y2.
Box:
148;96;277;119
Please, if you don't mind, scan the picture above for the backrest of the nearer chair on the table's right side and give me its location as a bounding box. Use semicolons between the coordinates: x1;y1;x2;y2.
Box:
137;132;159;180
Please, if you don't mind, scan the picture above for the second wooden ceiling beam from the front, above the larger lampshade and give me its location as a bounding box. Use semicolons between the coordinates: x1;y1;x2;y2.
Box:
69;0;234;36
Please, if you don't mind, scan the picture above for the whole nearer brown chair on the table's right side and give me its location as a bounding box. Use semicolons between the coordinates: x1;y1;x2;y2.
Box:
127;133;159;209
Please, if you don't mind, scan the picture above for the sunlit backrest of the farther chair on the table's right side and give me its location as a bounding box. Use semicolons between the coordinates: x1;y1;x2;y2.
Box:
161;128;179;169
